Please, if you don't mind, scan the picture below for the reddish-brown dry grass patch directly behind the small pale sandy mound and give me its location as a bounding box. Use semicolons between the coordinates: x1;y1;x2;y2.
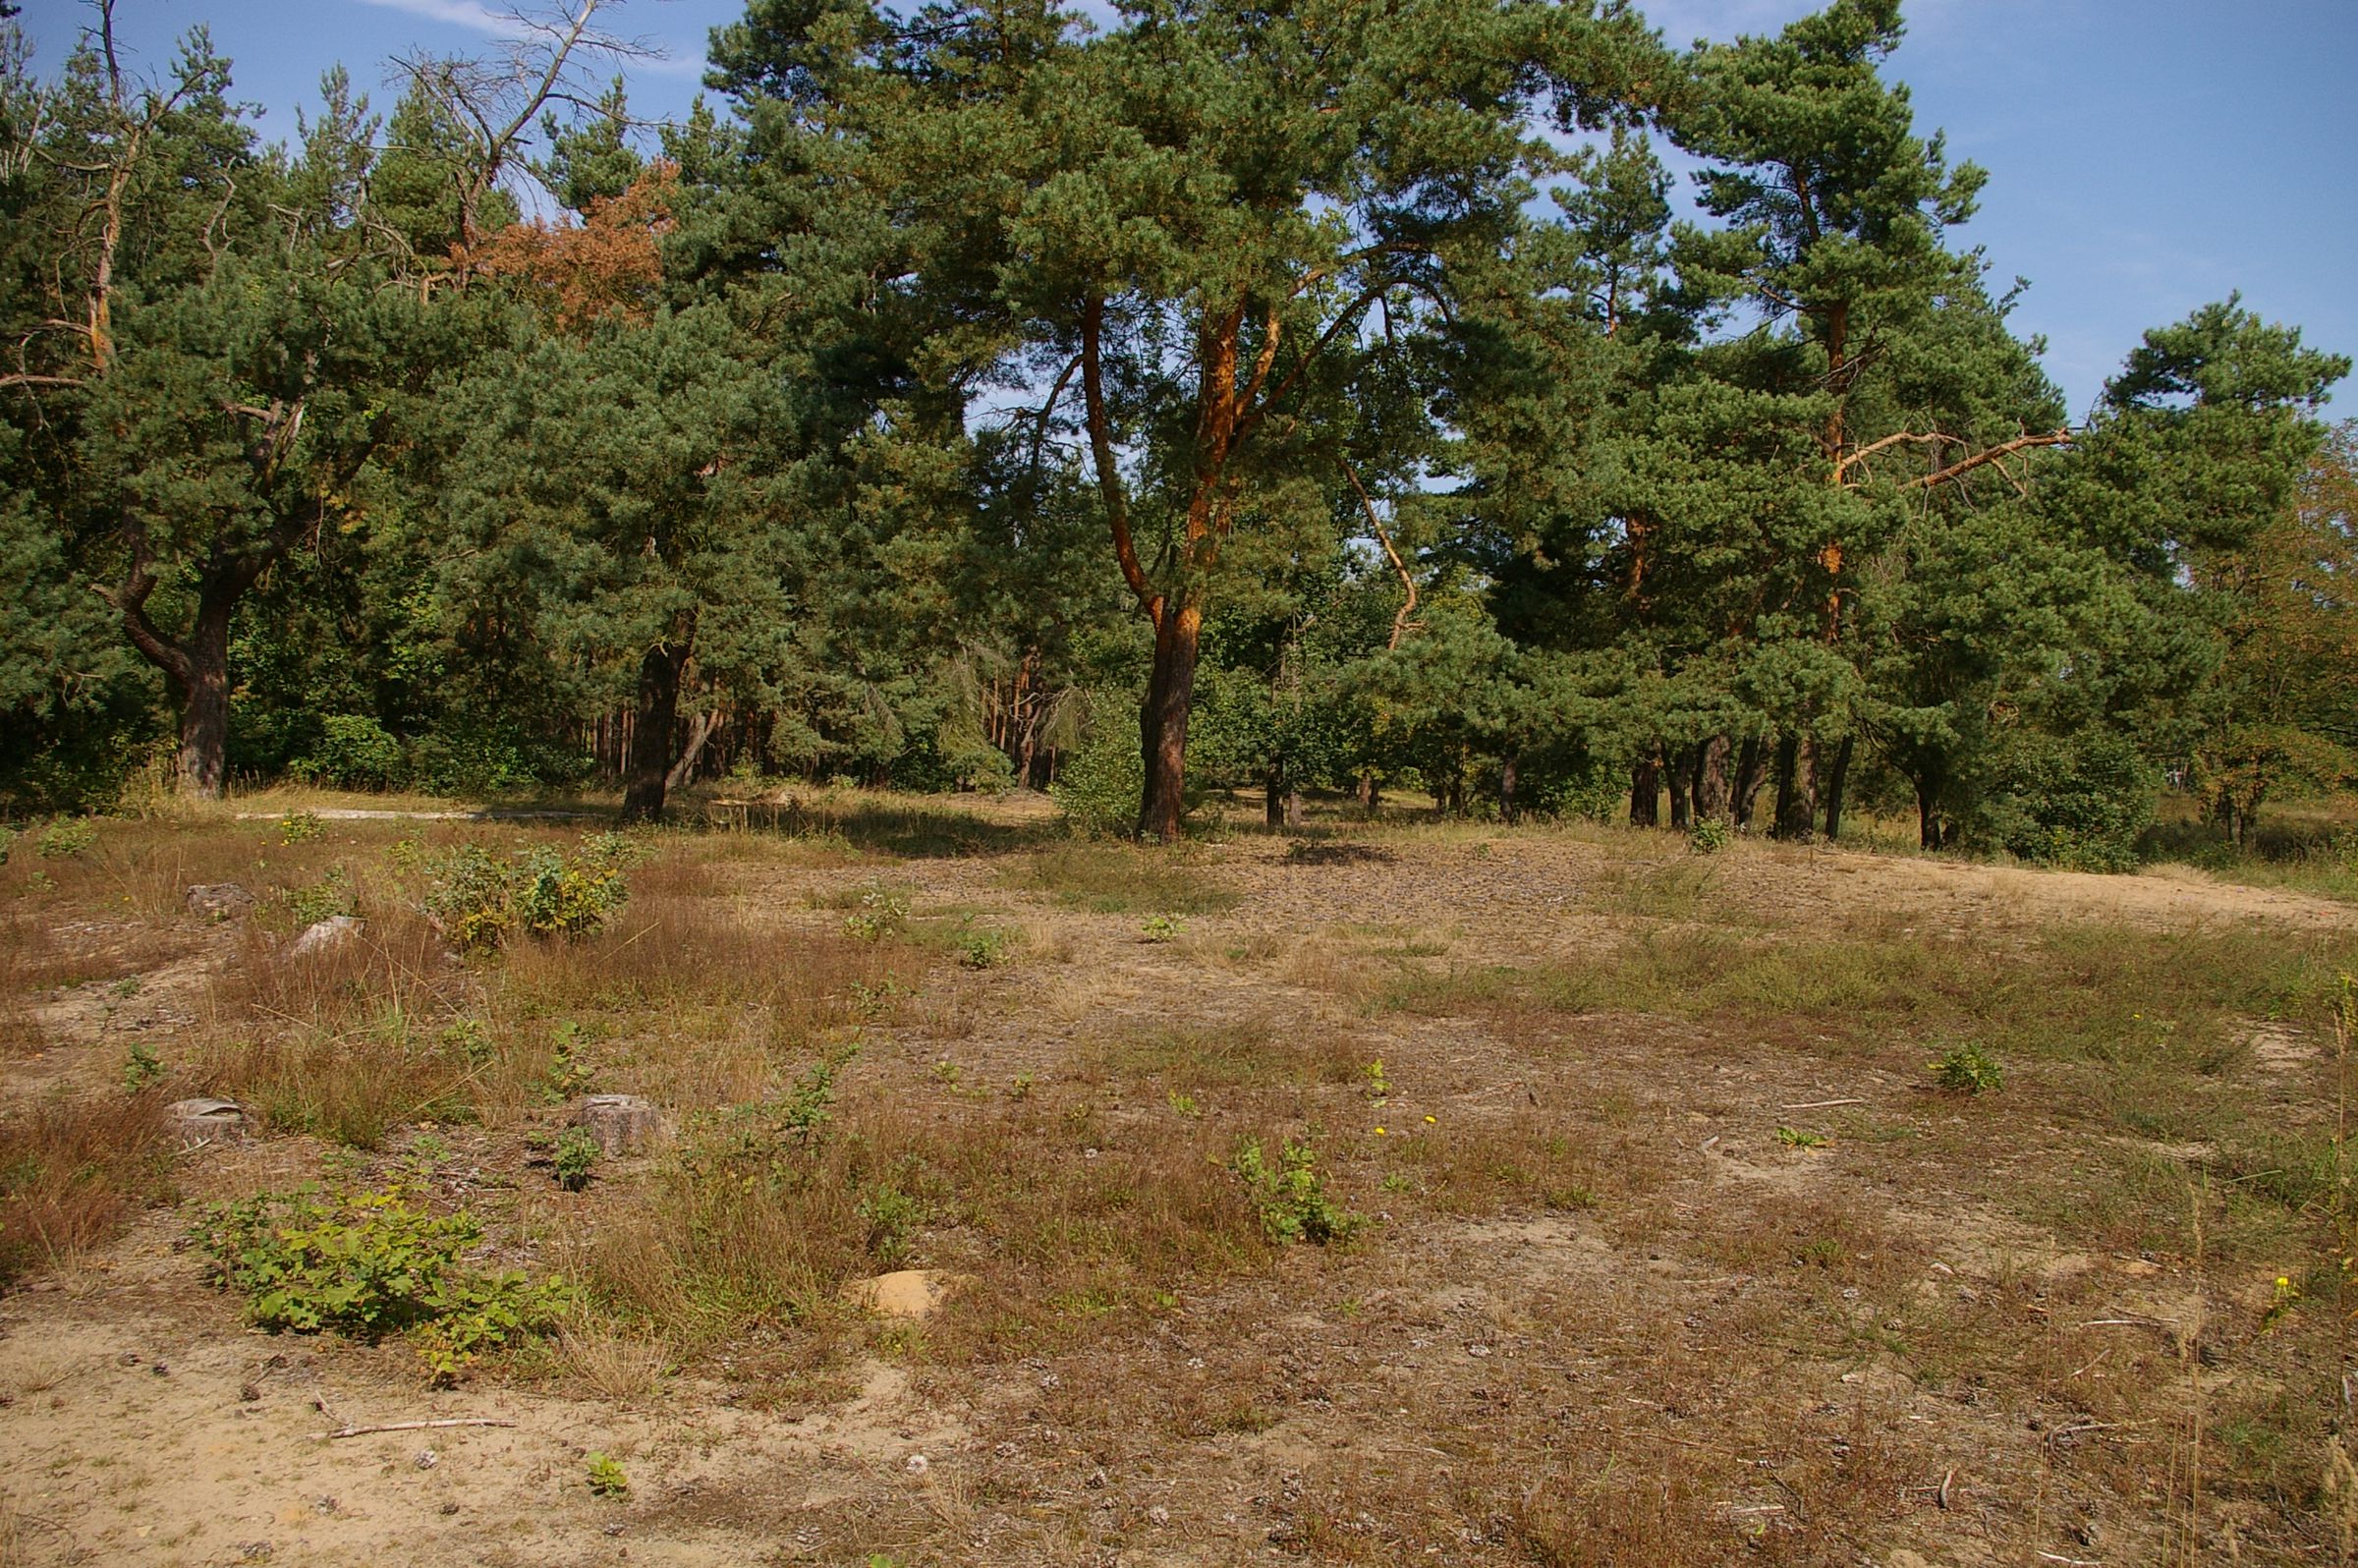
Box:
564;1094;1266;1358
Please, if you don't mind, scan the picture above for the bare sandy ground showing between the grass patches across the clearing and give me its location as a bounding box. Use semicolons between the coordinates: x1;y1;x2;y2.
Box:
0;835;2358;1568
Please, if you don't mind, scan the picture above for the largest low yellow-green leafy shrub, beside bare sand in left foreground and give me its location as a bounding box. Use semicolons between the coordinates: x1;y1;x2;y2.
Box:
194;1181;571;1381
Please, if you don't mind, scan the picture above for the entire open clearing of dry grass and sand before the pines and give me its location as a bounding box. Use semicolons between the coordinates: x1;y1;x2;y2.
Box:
0;797;2358;1566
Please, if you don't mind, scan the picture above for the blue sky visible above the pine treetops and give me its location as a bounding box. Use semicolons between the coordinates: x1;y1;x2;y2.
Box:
24;0;2358;415
